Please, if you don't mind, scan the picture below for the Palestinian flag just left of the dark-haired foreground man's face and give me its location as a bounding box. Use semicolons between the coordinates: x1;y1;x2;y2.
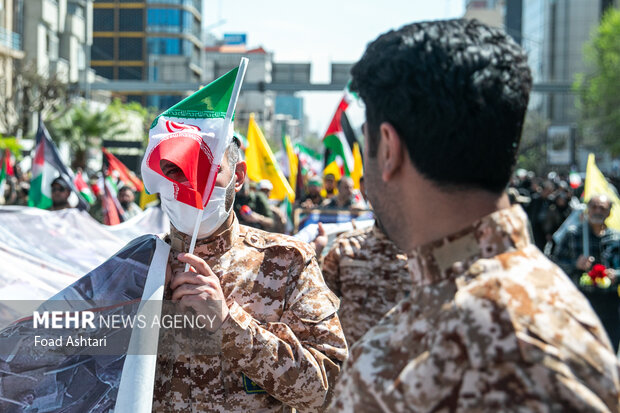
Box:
323;93;354;176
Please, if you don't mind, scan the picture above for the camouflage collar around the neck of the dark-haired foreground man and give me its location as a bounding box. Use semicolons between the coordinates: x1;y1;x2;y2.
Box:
407;205;531;286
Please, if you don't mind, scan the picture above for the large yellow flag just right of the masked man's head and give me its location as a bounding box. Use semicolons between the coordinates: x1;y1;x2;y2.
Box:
245;114;295;202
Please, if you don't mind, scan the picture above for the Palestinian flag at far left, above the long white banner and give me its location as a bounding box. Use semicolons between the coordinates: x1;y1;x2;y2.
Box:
28;120;89;210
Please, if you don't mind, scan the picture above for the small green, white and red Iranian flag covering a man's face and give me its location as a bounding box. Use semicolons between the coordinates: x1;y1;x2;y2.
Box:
142;59;247;214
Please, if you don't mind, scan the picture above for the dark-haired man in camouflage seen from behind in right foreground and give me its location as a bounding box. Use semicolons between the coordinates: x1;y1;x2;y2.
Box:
332;20;620;412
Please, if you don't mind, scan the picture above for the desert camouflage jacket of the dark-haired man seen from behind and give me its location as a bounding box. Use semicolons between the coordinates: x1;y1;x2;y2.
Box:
331;206;619;412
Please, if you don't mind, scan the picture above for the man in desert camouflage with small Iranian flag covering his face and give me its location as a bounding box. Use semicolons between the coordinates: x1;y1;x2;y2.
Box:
136;62;347;412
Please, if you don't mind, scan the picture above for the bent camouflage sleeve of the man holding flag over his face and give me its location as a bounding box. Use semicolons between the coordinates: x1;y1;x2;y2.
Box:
222;251;347;412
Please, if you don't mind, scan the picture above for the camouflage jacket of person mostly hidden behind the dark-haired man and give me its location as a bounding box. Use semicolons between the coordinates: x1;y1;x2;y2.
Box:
322;225;411;345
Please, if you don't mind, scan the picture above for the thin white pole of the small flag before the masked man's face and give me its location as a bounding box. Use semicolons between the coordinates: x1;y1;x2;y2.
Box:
185;57;248;272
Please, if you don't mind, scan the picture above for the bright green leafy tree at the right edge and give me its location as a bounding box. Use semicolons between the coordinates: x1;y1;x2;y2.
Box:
574;8;620;156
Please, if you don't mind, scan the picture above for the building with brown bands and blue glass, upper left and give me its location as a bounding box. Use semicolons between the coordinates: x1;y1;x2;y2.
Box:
91;0;204;109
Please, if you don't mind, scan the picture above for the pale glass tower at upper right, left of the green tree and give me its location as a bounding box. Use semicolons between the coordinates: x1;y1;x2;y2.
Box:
522;0;616;169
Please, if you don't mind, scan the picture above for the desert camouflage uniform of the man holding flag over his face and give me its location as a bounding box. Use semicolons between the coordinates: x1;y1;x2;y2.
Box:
153;219;347;412
